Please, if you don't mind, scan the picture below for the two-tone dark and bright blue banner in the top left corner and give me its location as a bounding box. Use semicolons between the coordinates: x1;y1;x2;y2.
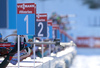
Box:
0;0;17;29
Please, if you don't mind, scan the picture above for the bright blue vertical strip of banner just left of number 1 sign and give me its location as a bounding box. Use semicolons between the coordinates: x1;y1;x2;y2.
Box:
8;0;17;29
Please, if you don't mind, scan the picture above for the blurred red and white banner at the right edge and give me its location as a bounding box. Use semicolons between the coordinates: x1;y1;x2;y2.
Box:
77;37;100;47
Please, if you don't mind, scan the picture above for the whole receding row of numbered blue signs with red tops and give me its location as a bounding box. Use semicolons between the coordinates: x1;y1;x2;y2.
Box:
17;3;65;42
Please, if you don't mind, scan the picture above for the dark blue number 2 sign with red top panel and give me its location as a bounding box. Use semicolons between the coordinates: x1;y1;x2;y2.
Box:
35;13;47;37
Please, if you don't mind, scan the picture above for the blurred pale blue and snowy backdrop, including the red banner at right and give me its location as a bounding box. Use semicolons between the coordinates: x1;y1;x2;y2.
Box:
0;0;100;68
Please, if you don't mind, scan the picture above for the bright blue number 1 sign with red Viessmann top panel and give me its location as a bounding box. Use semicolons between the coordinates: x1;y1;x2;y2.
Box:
17;3;35;35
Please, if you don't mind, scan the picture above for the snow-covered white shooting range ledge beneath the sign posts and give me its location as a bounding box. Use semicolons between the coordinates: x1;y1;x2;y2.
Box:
7;43;76;68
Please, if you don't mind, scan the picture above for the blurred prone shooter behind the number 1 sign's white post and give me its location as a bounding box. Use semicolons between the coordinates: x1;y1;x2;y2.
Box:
11;31;33;65
